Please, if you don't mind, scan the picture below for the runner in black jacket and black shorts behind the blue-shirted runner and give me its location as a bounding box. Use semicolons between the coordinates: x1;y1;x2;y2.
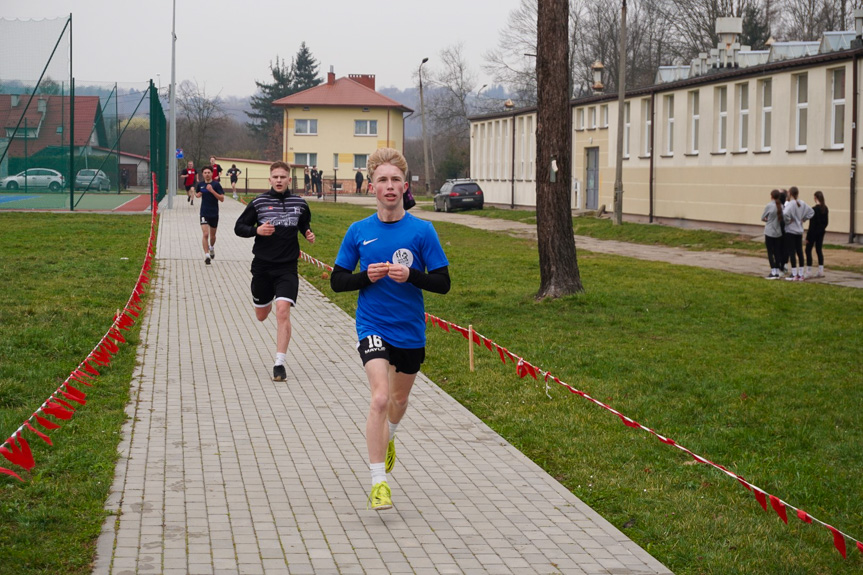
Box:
234;162;315;381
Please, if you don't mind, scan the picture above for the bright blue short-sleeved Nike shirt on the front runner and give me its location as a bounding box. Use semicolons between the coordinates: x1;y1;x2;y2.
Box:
336;213;449;349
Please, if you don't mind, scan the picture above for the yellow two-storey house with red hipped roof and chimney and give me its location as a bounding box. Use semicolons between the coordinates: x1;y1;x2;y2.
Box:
273;69;413;193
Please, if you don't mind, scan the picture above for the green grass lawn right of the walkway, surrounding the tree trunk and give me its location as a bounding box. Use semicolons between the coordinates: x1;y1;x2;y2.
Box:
301;204;863;575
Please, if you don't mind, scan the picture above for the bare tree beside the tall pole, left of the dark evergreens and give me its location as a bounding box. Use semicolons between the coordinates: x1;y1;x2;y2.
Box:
177;80;228;165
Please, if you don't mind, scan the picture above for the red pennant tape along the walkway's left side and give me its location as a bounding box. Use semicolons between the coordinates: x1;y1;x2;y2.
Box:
0;174;158;481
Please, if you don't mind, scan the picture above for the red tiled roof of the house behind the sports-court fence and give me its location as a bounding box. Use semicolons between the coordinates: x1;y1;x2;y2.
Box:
0;94;104;157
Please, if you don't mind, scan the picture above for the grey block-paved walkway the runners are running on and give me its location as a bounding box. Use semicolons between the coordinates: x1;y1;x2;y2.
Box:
93;197;670;575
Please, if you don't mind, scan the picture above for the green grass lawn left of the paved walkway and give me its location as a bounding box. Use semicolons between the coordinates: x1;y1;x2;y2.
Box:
0;213;150;575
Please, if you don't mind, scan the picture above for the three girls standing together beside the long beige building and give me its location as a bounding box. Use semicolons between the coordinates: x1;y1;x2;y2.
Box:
761;186;829;281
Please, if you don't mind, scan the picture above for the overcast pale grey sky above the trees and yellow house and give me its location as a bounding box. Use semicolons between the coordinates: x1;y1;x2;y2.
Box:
0;0;519;97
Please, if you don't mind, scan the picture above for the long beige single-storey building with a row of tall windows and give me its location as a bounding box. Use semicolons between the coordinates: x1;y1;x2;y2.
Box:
470;23;863;242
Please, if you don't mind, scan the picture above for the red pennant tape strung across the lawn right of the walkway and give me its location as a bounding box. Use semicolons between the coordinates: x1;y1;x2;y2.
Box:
426;313;863;558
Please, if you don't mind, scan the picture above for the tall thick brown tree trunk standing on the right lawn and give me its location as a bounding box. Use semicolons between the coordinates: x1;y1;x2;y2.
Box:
536;0;584;299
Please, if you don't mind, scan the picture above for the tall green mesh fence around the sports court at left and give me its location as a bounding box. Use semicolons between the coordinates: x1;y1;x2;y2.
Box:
0;15;167;210
